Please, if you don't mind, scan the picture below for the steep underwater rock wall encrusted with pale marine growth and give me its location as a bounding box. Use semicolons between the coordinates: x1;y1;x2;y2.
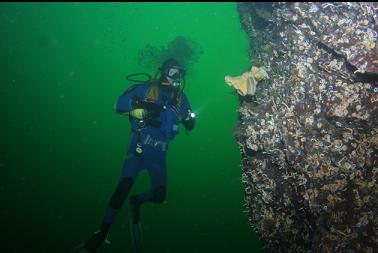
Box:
236;2;378;253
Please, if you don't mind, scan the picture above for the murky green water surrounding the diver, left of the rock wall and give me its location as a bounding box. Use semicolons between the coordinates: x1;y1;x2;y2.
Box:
0;3;262;253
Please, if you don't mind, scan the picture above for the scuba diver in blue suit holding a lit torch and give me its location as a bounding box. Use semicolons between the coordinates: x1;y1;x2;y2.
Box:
72;58;195;253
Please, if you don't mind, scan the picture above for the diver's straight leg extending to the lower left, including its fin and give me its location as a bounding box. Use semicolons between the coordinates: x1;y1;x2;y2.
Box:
84;157;141;252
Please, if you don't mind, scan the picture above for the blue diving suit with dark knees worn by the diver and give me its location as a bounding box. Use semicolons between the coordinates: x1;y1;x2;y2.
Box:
104;83;195;224
